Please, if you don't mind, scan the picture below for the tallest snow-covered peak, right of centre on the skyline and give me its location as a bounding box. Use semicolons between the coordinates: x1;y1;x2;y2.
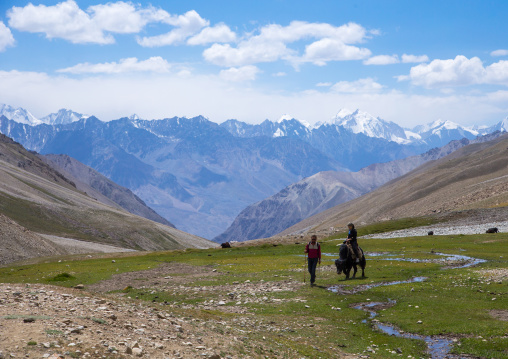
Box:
315;109;411;144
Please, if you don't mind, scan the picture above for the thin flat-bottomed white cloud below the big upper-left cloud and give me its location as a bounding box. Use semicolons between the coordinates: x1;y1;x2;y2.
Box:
57;56;171;74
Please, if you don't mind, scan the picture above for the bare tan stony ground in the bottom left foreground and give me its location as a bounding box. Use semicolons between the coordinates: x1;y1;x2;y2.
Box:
0;264;355;359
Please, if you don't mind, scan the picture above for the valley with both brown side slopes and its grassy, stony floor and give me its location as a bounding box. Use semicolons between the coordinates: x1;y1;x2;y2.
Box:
0;107;508;359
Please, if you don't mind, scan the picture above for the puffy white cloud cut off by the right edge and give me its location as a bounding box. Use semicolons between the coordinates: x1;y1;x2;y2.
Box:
398;55;508;88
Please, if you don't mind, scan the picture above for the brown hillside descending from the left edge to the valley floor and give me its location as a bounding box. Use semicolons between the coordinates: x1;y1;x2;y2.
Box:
0;135;214;264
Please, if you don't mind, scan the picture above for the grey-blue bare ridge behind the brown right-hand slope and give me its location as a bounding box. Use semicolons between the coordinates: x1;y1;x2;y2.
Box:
214;138;470;242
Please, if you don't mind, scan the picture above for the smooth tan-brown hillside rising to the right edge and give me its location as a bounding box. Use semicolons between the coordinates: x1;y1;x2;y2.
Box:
280;134;508;235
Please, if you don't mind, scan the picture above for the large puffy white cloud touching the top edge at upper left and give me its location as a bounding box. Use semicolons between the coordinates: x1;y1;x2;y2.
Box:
7;0;170;44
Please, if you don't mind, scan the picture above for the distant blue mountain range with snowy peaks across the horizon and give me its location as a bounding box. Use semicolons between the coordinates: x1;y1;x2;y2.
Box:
0;102;508;238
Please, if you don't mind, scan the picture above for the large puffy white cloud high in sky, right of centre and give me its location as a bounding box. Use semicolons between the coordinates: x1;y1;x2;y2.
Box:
203;21;371;67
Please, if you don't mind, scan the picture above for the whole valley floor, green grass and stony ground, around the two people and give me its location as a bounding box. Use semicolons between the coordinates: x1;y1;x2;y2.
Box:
0;233;508;358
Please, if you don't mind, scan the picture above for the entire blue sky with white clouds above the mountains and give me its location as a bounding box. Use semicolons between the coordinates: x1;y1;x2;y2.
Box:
0;0;508;128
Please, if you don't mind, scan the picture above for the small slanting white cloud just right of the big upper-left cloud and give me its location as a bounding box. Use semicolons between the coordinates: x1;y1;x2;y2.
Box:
138;10;210;47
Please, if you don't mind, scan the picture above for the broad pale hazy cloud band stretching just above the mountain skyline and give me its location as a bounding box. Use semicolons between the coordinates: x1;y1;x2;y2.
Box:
0;71;508;127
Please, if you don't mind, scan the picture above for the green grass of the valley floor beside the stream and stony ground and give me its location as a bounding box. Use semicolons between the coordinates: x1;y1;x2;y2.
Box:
0;232;508;358
